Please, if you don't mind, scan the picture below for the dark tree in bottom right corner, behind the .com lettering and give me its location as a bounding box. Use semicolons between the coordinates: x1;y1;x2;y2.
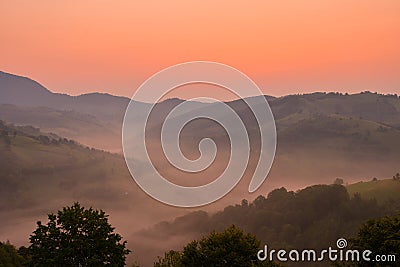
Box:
351;214;400;266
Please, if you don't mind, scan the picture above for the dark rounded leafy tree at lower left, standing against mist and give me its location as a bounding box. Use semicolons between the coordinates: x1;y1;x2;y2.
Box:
29;203;130;266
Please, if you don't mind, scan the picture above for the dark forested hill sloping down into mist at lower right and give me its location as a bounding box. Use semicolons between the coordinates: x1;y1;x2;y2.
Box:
132;180;400;262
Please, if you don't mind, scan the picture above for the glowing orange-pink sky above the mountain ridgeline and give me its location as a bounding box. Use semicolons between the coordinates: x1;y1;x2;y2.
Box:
0;0;400;97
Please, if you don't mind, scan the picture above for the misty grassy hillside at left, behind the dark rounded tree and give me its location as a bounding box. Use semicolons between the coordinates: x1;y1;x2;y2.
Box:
0;121;185;249
